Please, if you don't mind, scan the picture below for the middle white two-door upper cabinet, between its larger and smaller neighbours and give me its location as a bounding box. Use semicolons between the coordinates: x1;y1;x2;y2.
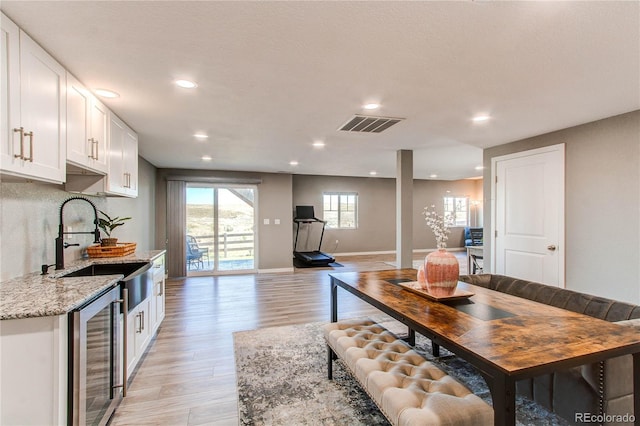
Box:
67;73;109;174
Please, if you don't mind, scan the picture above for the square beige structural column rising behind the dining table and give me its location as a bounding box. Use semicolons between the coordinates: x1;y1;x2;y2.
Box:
396;150;413;268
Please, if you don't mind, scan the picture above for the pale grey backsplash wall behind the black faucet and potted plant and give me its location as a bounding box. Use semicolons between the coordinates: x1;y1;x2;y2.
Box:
0;159;156;281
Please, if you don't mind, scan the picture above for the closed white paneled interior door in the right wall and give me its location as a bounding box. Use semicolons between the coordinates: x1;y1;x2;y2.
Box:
492;144;565;287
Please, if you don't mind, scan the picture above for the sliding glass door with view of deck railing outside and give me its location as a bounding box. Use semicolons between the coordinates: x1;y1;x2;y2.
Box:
185;183;257;276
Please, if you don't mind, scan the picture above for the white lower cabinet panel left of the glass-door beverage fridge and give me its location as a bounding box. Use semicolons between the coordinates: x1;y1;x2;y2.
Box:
0;315;68;425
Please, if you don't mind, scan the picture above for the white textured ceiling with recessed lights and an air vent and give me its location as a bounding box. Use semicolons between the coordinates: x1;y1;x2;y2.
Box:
0;0;640;179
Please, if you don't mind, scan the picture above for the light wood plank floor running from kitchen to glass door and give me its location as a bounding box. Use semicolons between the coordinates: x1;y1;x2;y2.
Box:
111;254;466;426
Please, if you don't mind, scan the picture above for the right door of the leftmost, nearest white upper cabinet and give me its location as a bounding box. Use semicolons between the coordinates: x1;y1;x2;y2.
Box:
14;31;66;183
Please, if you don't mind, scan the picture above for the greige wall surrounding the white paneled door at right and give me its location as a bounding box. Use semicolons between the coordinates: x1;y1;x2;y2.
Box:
484;111;640;303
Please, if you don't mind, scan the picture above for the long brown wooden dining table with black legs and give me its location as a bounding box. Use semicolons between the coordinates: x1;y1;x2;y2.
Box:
329;269;640;426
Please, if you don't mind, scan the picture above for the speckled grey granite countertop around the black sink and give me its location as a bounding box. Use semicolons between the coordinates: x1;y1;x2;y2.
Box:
0;250;165;320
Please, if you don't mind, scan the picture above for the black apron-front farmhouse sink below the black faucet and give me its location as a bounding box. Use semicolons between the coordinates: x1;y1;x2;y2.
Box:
62;262;153;312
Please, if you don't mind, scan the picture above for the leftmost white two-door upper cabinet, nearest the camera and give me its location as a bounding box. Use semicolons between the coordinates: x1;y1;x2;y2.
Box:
0;14;66;183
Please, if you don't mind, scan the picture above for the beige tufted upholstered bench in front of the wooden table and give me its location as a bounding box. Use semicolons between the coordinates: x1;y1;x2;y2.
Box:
324;320;493;426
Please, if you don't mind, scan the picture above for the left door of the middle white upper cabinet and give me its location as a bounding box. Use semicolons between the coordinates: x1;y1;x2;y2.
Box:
67;74;93;167
